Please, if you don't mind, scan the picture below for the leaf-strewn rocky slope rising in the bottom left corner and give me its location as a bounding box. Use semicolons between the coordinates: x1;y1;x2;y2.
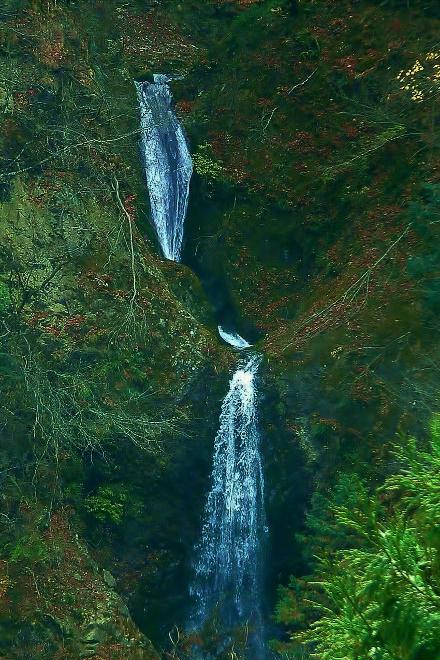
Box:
2;509;159;660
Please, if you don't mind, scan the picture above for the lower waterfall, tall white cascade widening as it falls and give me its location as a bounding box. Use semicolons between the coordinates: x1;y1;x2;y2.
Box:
191;354;265;658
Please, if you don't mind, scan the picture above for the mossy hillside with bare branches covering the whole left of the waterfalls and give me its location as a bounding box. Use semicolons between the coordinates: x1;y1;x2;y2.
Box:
0;2;229;658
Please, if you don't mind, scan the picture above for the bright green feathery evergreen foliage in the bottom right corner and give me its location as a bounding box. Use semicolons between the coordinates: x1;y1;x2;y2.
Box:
284;416;440;660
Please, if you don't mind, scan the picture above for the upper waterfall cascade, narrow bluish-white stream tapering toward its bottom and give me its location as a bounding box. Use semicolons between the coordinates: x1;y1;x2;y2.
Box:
135;74;193;261
